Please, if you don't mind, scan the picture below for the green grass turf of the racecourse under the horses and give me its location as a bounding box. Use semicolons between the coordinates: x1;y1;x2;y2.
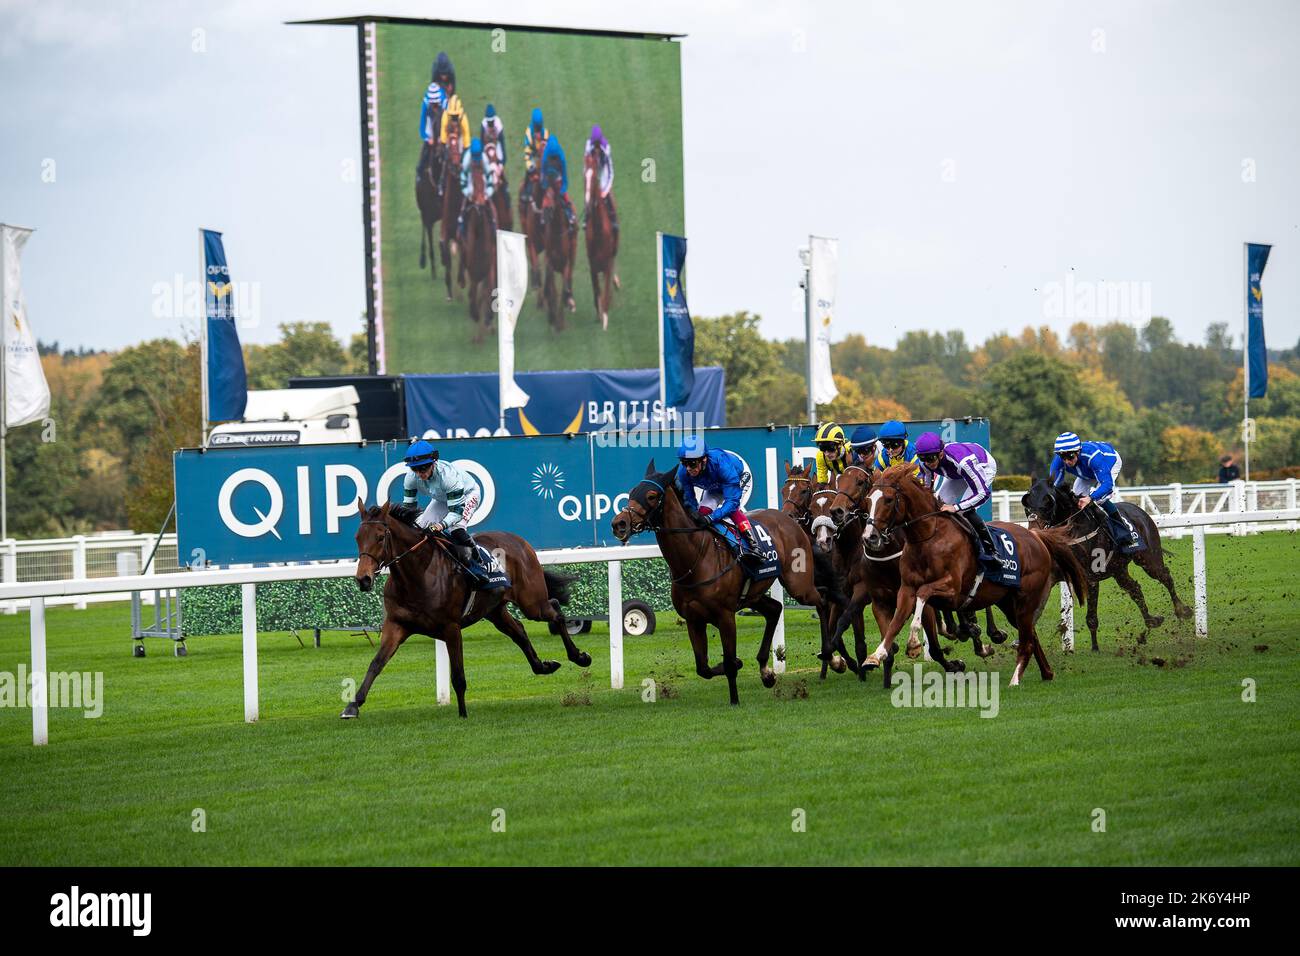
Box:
0;533;1300;865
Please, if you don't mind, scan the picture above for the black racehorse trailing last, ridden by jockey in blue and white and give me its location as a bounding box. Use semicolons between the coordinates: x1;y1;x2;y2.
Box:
1021;481;1192;650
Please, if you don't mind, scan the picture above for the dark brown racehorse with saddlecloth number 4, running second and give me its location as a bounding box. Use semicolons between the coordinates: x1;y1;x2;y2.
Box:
611;460;828;704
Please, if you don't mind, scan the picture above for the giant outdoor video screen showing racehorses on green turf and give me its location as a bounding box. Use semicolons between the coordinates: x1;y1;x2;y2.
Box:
363;22;685;373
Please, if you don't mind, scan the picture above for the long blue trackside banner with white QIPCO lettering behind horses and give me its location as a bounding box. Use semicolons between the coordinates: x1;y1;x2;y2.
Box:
176;427;790;566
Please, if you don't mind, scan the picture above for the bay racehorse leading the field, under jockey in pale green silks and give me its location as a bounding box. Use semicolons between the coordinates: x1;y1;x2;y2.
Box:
339;501;592;718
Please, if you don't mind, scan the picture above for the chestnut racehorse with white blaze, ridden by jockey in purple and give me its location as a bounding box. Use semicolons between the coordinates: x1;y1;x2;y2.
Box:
863;463;1088;687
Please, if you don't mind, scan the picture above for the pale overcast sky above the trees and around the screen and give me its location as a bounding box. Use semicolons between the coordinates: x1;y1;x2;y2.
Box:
0;0;1300;358
